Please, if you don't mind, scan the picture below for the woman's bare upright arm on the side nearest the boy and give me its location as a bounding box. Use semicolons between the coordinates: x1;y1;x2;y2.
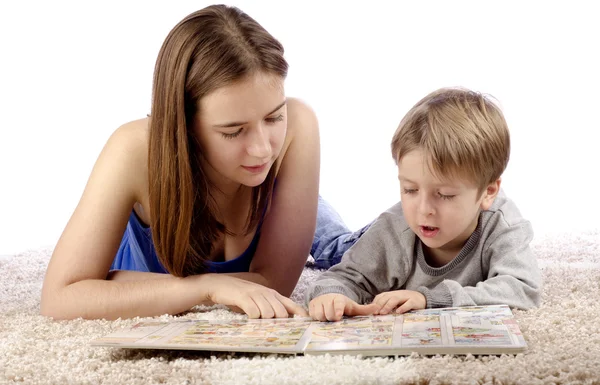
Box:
246;98;320;296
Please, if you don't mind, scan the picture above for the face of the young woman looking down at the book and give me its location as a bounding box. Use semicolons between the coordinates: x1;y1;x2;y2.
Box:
194;73;287;187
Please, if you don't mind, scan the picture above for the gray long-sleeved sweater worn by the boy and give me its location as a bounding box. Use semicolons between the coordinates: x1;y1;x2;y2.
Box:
306;191;542;309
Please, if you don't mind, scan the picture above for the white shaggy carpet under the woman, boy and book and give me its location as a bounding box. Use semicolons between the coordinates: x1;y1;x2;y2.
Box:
0;231;600;385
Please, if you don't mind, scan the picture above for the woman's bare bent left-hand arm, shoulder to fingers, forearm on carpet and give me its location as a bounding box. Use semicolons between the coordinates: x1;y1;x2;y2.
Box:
41;120;306;319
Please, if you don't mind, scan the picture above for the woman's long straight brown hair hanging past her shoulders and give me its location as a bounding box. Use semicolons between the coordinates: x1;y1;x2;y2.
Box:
148;5;288;277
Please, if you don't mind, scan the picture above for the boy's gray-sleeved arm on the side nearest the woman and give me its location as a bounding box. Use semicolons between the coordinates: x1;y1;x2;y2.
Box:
306;208;409;304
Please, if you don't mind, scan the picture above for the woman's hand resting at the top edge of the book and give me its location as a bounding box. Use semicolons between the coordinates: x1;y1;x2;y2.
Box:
204;274;308;318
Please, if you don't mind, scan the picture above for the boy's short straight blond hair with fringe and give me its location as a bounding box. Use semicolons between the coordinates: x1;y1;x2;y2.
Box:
392;88;510;191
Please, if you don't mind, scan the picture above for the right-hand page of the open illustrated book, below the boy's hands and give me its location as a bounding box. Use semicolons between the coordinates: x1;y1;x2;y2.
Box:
305;305;527;356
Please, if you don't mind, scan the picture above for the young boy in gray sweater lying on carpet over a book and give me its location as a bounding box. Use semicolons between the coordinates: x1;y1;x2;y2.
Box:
306;88;542;321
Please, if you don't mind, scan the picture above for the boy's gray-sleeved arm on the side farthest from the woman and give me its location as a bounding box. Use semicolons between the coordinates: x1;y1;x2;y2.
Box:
418;222;542;309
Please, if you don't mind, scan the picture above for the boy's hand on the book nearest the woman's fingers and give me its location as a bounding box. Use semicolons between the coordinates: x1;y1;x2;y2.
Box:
308;294;379;321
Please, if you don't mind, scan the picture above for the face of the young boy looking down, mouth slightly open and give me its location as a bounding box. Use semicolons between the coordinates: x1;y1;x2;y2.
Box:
398;149;500;254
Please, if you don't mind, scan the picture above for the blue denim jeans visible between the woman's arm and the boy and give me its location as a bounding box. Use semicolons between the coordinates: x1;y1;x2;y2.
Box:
310;195;371;269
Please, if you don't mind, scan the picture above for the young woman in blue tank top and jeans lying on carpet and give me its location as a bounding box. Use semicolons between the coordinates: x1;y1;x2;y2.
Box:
41;6;360;319
